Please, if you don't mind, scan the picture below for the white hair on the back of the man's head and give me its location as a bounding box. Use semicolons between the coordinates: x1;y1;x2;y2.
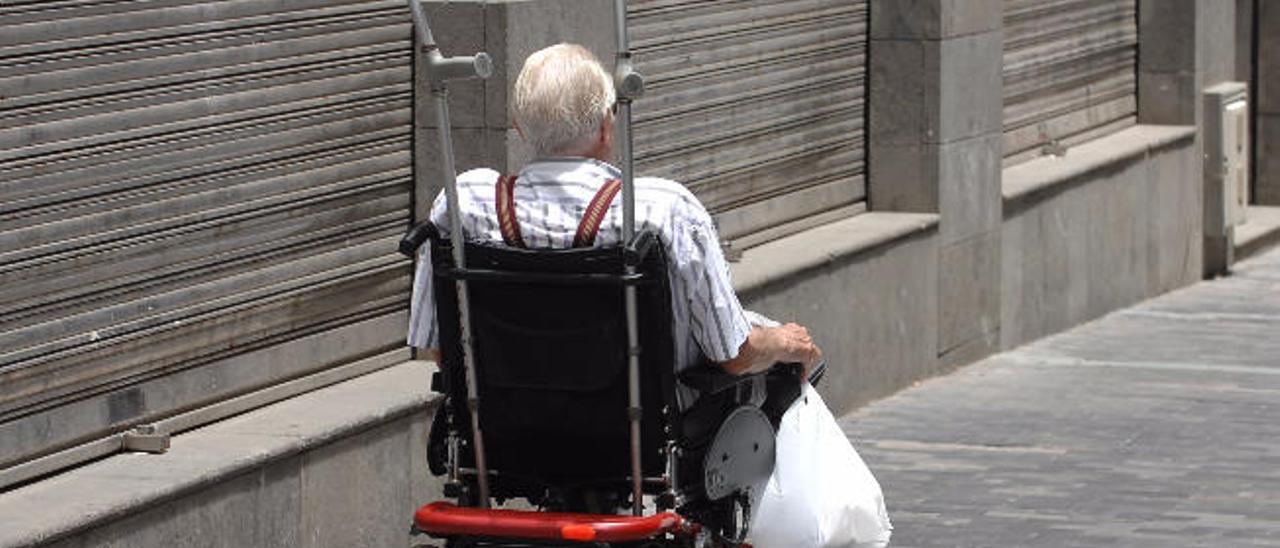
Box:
515;44;616;156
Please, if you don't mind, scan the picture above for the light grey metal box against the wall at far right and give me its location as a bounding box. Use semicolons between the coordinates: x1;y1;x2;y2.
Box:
1204;82;1249;237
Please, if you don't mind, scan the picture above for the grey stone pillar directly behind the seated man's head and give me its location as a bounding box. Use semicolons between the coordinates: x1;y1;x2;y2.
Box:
413;0;617;218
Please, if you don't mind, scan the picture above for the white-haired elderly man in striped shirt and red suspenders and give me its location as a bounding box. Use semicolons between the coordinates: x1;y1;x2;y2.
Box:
408;44;822;384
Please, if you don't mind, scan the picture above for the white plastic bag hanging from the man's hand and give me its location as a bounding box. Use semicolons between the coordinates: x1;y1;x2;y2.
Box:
748;383;893;548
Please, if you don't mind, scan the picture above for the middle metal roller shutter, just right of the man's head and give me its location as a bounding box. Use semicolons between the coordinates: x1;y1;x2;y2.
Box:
628;0;868;244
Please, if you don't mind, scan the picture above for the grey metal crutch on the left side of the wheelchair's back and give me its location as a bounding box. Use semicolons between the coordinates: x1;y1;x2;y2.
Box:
408;0;493;507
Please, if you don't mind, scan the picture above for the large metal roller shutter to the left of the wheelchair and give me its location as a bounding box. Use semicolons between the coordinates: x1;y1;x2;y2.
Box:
0;0;412;469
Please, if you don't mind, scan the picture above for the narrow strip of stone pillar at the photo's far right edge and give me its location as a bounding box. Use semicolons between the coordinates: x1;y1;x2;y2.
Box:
1253;0;1280;206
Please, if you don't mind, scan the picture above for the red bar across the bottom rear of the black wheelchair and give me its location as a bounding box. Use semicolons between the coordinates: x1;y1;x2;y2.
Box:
413;501;694;543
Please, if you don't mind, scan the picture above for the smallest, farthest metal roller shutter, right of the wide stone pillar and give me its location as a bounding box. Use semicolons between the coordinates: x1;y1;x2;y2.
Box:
1004;0;1138;163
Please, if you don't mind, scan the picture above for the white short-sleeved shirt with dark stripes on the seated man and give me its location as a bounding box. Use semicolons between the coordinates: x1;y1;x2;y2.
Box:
408;157;751;376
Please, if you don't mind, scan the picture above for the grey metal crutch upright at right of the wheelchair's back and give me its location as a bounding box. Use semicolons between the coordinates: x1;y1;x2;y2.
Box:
613;0;644;516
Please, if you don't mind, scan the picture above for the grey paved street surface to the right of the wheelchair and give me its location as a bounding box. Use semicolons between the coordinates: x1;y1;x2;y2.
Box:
842;251;1280;547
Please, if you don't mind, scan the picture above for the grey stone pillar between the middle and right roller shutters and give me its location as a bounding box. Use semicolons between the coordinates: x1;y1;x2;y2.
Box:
868;0;1004;366
